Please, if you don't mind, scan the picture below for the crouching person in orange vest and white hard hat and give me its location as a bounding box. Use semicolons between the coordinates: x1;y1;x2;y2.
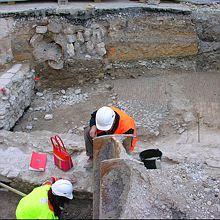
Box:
84;106;137;167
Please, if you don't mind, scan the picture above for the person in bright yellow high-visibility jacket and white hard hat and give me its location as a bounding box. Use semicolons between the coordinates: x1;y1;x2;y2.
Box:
16;177;73;219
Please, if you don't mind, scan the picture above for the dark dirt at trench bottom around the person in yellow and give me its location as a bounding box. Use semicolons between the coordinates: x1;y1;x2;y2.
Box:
0;191;92;219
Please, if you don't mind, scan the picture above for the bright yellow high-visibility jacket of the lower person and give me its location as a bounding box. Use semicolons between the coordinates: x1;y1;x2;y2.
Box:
16;185;59;219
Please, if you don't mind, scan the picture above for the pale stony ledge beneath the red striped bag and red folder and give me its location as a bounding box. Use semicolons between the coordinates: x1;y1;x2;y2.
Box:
0;130;92;193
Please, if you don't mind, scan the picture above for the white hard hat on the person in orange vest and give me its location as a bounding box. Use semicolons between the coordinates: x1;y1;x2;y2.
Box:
96;106;115;131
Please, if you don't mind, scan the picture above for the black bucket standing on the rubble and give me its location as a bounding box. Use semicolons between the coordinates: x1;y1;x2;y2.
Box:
139;149;162;169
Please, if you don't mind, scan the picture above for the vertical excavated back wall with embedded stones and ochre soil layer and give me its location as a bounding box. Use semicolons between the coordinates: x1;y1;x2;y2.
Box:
0;7;220;86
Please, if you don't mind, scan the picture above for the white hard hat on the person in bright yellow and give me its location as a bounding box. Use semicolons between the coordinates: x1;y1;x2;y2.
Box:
51;179;73;199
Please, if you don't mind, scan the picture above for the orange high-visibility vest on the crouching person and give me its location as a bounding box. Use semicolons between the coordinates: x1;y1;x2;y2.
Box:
111;106;138;151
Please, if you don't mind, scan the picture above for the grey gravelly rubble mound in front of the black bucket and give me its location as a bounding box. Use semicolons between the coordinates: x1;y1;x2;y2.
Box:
100;159;219;219
